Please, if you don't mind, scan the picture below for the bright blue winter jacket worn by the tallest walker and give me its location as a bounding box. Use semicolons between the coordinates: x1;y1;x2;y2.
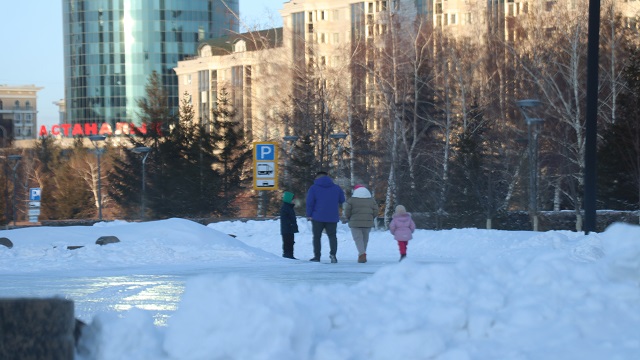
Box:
307;176;345;223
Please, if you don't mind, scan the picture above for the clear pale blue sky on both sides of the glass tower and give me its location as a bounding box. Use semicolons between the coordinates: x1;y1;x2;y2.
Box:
0;0;285;127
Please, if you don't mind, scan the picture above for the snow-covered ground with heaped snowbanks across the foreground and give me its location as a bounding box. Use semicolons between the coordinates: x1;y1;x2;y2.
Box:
0;218;640;360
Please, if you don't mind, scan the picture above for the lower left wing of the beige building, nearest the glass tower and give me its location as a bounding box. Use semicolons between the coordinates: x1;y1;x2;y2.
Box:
174;28;288;139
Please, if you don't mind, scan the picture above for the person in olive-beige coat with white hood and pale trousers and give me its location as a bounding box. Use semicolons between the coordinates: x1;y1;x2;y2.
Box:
344;185;378;263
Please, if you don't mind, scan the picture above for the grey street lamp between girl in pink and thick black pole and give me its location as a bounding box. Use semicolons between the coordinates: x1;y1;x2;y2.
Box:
516;99;544;231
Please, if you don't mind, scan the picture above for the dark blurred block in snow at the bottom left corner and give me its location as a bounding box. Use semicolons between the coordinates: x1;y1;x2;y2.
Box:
0;298;76;360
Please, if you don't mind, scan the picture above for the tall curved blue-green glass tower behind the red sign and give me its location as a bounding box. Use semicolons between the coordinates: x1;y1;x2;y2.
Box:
63;0;239;127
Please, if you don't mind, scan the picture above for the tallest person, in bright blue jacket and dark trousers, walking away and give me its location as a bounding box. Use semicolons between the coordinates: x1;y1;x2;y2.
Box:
307;171;345;263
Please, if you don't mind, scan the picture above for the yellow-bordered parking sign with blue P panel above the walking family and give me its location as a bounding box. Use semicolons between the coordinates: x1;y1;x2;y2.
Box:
253;142;278;190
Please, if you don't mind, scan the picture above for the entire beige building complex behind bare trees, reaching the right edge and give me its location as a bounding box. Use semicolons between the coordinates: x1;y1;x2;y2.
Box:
175;0;640;141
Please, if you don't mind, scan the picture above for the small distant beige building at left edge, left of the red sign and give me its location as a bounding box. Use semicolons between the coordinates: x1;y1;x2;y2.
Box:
0;85;43;147
